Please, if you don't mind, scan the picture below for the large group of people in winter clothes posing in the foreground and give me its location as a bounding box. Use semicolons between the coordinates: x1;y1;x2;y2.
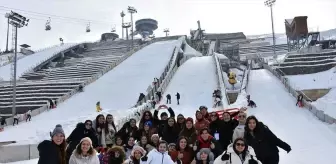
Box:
38;106;291;164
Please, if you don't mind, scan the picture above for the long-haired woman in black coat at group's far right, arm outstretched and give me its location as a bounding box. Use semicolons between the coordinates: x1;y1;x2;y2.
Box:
245;116;292;164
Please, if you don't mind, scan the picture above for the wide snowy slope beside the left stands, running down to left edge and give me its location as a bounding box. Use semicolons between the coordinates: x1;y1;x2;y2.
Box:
0;40;181;144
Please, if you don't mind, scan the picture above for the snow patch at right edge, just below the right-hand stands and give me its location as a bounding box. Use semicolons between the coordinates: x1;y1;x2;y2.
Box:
286;67;336;90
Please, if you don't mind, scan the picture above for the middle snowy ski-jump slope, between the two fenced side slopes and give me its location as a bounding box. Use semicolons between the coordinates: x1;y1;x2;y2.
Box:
159;56;217;117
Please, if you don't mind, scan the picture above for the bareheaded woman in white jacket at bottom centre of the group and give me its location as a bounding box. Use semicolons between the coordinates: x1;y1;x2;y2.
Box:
140;141;174;164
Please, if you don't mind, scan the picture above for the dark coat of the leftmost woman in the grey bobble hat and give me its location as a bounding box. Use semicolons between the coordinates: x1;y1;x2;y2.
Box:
37;140;61;164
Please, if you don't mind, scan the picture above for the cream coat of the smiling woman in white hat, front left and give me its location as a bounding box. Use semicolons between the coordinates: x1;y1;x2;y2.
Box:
69;150;99;164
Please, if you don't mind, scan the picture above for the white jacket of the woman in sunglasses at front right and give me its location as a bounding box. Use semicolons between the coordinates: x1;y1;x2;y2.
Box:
213;144;262;164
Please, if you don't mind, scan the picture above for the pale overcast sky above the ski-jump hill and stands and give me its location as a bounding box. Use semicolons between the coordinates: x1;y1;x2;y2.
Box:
0;0;336;49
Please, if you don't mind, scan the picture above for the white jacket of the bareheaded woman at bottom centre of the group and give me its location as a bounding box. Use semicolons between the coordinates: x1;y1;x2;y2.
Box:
140;149;174;164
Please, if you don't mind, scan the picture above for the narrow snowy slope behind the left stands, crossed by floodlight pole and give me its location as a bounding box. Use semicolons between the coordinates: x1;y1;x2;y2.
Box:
0;43;75;81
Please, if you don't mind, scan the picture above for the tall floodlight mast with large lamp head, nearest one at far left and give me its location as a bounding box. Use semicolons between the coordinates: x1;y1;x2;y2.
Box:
5;11;29;116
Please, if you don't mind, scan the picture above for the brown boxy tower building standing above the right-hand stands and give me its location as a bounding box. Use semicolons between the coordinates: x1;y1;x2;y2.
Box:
285;16;320;51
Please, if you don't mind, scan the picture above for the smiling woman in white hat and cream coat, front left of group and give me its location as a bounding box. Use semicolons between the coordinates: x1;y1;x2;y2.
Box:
69;137;99;164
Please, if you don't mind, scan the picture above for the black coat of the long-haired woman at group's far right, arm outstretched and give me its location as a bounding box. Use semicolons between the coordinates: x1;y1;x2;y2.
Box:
244;122;291;163
